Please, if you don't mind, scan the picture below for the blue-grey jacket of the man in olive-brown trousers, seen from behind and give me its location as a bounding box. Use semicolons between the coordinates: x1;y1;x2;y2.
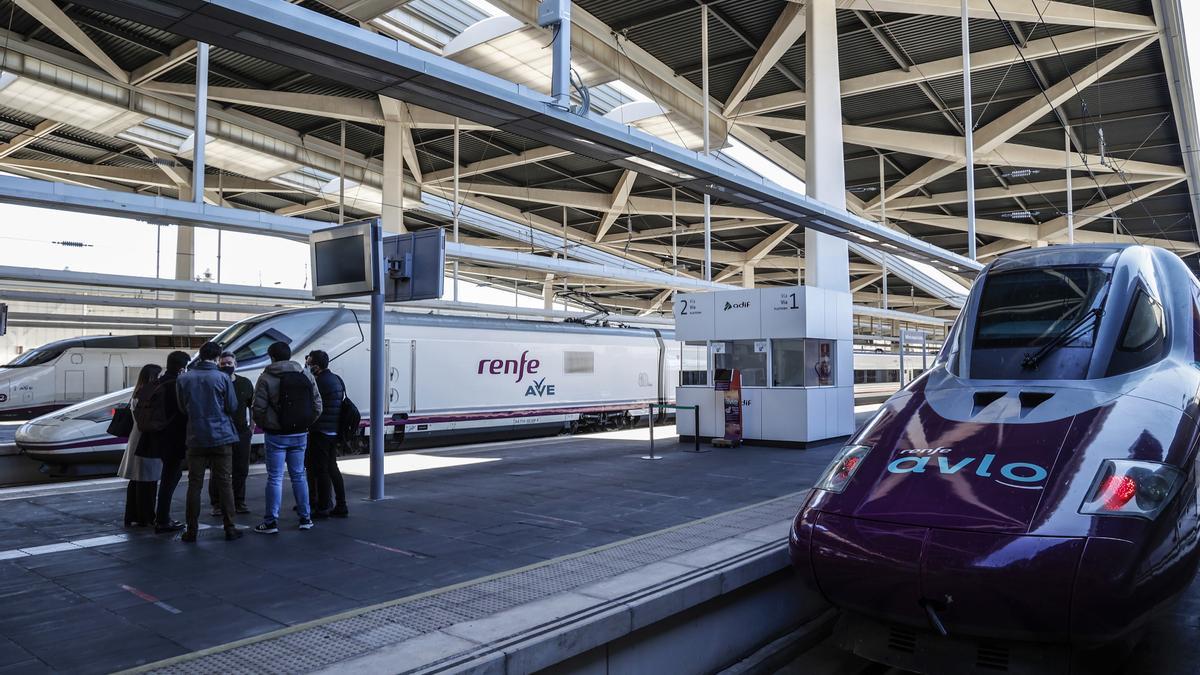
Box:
175;362;238;448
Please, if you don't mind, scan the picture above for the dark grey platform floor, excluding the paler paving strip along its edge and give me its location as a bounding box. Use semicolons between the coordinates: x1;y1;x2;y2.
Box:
0;430;836;673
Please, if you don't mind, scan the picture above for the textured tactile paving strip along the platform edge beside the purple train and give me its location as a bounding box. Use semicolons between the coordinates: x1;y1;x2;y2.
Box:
149;492;806;675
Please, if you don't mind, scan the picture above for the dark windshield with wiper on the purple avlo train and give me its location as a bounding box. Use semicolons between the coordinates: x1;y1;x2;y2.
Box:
971;267;1109;380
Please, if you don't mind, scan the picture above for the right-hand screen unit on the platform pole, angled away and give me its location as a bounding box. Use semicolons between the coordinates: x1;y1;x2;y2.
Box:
383;227;446;303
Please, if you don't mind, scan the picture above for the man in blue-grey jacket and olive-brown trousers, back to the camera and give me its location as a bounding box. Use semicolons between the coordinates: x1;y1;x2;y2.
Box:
176;342;241;542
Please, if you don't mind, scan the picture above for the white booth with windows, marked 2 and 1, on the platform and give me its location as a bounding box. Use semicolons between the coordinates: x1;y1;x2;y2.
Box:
674;286;854;446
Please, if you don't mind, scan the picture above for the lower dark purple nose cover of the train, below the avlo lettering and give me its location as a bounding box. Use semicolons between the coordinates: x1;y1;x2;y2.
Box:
793;513;1086;640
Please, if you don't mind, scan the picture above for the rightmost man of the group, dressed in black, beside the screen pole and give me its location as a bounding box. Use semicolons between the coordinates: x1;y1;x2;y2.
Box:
305;350;350;518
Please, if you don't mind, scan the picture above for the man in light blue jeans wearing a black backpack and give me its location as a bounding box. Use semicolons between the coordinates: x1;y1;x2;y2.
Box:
252;342;322;534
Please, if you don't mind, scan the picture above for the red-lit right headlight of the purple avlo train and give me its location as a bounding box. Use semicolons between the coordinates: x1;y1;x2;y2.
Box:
1079;459;1183;520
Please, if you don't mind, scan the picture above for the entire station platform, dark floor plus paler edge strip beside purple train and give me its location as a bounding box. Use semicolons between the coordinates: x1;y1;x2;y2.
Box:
0;422;838;673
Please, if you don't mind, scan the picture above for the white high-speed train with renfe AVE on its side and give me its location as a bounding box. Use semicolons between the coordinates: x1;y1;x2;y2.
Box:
16;307;679;468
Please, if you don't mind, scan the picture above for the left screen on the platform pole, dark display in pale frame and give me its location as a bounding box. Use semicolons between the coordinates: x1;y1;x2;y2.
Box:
308;222;374;300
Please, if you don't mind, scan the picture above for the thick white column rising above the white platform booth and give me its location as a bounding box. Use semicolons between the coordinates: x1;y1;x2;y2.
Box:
804;0;850;292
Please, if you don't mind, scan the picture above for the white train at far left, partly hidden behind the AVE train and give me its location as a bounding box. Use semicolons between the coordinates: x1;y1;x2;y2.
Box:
0;335;205;419
